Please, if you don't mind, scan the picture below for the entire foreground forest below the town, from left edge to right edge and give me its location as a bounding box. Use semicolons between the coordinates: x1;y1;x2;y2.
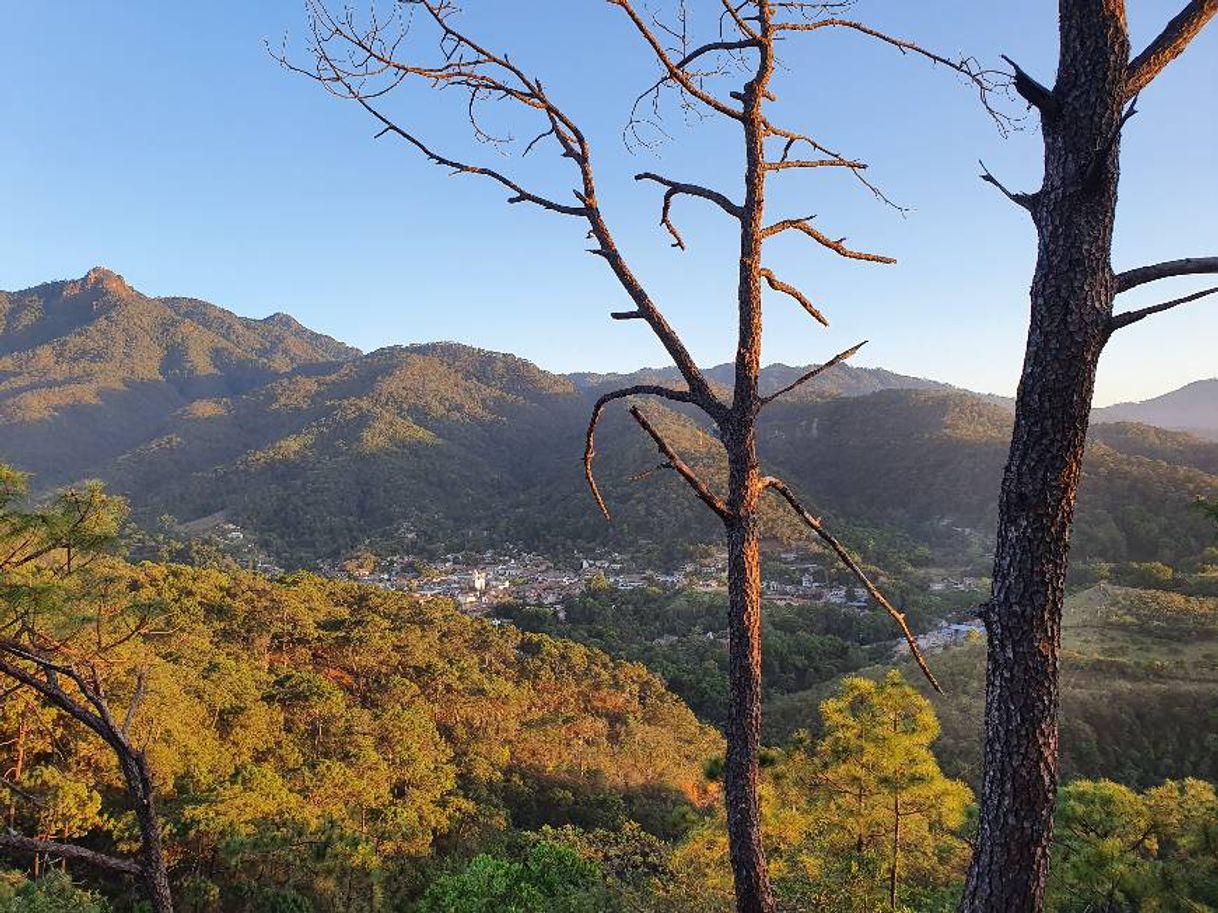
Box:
0;470;1218;913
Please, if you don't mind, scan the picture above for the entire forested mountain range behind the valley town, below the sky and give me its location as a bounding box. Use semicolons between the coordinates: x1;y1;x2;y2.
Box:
0;269;1218;564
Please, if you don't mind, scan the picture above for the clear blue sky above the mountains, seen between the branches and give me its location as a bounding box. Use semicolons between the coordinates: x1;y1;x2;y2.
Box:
0;0;1218;404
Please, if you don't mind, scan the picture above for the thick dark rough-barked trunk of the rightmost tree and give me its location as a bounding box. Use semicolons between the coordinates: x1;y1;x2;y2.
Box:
961;0;1129;913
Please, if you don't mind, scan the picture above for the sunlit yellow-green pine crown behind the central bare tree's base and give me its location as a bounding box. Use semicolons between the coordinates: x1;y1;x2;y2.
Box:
661;673;972;913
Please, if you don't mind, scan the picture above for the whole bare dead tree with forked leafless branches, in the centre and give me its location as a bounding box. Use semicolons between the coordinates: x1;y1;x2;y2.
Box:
287;0;1008;913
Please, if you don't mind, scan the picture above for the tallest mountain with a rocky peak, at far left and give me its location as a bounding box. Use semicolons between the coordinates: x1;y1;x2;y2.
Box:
0;268;354;484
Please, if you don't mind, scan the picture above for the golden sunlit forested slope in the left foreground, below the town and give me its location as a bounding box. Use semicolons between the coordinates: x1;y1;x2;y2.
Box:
0;467;720;913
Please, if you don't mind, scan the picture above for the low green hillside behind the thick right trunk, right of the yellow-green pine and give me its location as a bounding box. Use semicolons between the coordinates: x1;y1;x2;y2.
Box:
769;584;1218;788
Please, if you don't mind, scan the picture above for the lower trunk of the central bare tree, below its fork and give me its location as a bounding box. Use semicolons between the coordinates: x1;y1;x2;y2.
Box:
723;422;773;913
